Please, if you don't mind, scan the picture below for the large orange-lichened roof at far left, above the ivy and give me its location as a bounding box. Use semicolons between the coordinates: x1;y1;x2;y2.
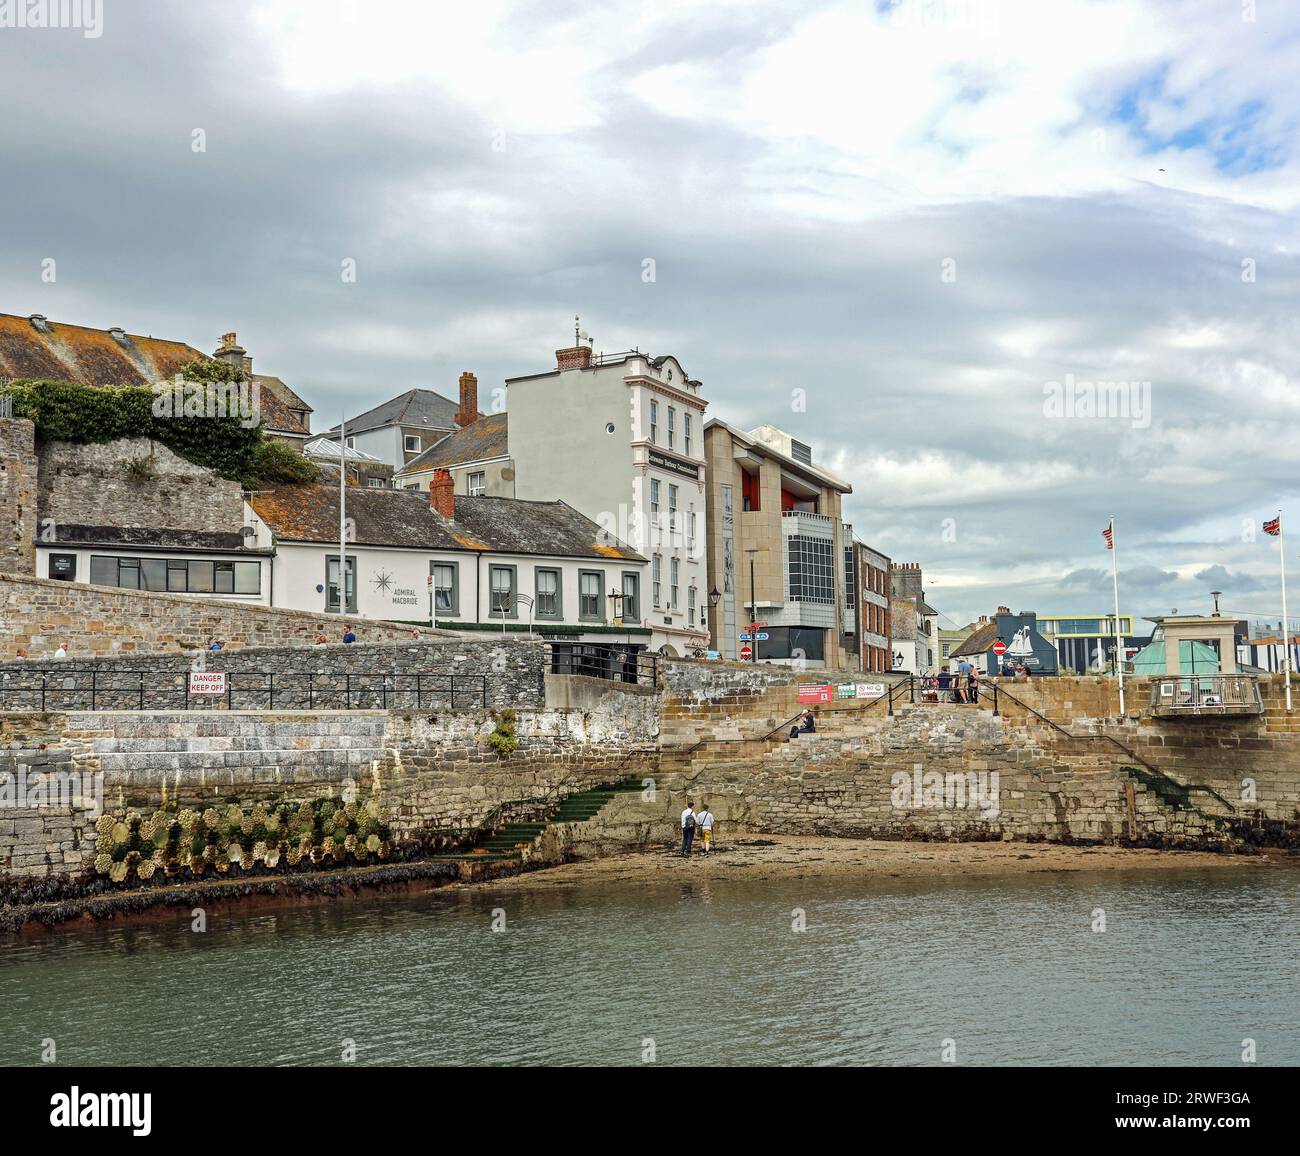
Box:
0;313;208;385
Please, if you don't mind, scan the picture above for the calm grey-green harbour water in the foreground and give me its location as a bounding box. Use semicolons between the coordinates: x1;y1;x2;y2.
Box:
0;870;1300;1065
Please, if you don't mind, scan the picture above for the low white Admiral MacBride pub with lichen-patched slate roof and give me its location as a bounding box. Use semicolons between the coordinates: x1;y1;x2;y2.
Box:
247;472;649;649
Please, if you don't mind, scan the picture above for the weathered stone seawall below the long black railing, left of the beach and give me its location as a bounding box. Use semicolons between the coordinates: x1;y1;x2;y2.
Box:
0;693;659;882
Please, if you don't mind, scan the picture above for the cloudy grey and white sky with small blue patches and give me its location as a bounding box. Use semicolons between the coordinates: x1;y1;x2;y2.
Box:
0;0;1300;631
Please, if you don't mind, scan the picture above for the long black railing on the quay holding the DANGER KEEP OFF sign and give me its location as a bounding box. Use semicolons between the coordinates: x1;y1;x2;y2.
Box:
0;666;489;711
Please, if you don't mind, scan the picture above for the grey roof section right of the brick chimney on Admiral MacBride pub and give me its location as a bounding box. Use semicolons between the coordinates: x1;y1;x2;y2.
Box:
455;494;645;562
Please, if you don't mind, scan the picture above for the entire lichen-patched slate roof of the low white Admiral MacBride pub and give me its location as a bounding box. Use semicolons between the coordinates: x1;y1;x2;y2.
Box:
248;485;645;562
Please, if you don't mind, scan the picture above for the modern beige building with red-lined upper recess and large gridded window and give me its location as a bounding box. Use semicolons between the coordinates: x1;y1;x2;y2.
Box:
705;419;858;670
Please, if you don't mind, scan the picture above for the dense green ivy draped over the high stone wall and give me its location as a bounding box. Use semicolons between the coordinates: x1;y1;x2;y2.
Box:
4;361;320;489
